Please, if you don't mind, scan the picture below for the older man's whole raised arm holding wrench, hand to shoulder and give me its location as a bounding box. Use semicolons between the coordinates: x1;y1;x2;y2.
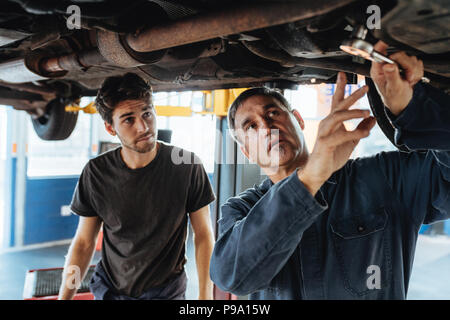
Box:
367;42;450;225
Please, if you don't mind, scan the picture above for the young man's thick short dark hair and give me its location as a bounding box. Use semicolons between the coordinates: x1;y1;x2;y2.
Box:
95;72;152;124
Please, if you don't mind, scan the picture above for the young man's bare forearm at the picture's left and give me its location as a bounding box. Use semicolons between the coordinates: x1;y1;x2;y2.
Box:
58;217;102;300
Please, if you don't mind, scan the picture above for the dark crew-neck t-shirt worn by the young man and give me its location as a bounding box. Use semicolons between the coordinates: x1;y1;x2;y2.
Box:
70;141;215;297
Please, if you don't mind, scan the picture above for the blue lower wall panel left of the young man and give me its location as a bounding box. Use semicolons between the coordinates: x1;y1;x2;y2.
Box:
24;177;78;245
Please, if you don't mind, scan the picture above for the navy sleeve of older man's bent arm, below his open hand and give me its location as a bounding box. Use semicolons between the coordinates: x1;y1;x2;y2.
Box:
210;172;327;295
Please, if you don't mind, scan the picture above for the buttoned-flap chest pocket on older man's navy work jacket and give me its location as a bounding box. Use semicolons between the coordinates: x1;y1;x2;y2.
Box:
331;208;392;296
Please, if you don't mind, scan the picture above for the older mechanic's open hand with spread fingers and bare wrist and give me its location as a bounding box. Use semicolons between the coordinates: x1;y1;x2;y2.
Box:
297;72;376;196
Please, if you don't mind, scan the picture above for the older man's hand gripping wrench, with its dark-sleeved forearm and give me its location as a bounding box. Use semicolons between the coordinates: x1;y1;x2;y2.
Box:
371;41;450;150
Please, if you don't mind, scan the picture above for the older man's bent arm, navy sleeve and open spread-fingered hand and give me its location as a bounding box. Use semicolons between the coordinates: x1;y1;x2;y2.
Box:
211;73;375;295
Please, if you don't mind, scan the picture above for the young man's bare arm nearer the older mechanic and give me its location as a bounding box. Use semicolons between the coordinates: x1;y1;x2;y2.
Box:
189;205;214;300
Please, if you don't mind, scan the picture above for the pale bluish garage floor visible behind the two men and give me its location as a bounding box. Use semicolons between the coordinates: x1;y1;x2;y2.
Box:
0;233;450;300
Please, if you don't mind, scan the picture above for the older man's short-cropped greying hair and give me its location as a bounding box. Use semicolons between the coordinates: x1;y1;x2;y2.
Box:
227;87;292;142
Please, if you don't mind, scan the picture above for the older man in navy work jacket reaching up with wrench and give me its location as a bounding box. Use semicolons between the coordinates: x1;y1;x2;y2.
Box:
210;42;450;299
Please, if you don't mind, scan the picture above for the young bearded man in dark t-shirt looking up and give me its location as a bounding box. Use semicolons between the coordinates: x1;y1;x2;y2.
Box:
59;73;215;300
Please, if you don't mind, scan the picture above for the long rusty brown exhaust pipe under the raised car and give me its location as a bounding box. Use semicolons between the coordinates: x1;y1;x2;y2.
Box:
0;0;355;83
